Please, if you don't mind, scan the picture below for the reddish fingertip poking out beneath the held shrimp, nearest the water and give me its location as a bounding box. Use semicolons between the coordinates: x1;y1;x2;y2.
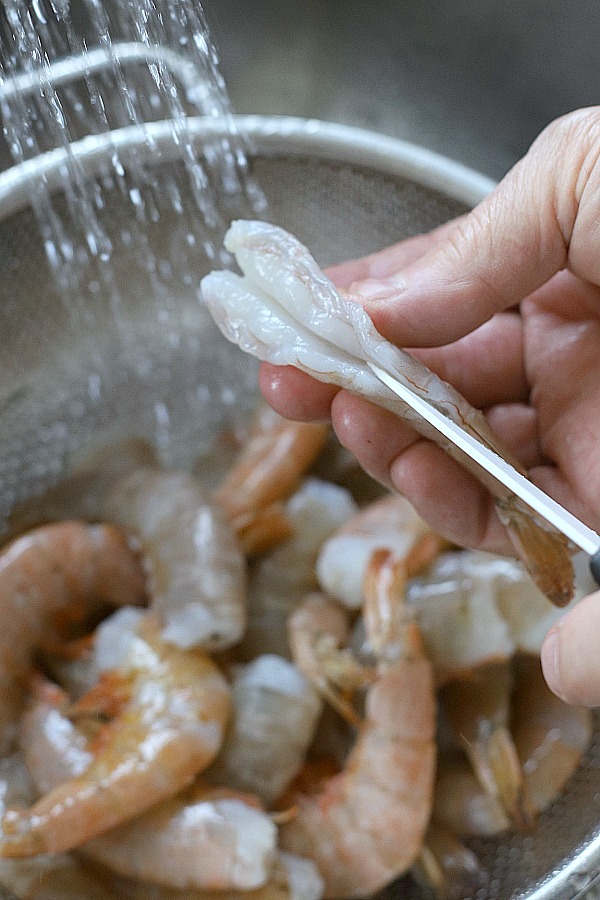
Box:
258;363;339;422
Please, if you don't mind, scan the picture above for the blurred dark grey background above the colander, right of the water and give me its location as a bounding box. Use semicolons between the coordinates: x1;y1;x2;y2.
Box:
204;0;600;178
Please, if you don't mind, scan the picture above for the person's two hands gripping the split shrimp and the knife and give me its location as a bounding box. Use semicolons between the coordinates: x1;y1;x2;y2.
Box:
261;108;600;706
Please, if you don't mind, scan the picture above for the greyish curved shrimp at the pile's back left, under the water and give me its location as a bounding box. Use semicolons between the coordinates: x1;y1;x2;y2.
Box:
8;440;246;650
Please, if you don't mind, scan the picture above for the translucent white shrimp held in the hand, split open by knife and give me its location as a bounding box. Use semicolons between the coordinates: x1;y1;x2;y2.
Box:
201;221;573;606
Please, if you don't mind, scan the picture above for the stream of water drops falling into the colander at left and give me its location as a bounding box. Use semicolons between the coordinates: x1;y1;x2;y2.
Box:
0;0;265;478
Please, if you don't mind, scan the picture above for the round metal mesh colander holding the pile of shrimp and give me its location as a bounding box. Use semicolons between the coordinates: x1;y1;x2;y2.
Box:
0;89;600;900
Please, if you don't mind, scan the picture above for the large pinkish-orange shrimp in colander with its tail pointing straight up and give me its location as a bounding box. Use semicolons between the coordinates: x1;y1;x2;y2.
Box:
281;554;435;898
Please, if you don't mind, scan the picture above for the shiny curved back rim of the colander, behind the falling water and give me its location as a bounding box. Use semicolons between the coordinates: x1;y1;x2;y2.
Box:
0;115;495;220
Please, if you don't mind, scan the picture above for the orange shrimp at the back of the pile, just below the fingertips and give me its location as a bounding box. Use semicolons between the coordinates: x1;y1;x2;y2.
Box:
215;404;329;554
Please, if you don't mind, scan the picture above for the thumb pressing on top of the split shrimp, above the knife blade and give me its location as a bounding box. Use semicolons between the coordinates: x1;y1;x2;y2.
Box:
353;107;600;347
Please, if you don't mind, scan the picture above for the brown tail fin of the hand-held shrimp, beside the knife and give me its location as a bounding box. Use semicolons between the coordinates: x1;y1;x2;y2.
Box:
496;500;574;607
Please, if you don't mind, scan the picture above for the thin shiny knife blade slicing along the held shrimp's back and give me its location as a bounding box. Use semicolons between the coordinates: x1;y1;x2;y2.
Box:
368;362;600;584
